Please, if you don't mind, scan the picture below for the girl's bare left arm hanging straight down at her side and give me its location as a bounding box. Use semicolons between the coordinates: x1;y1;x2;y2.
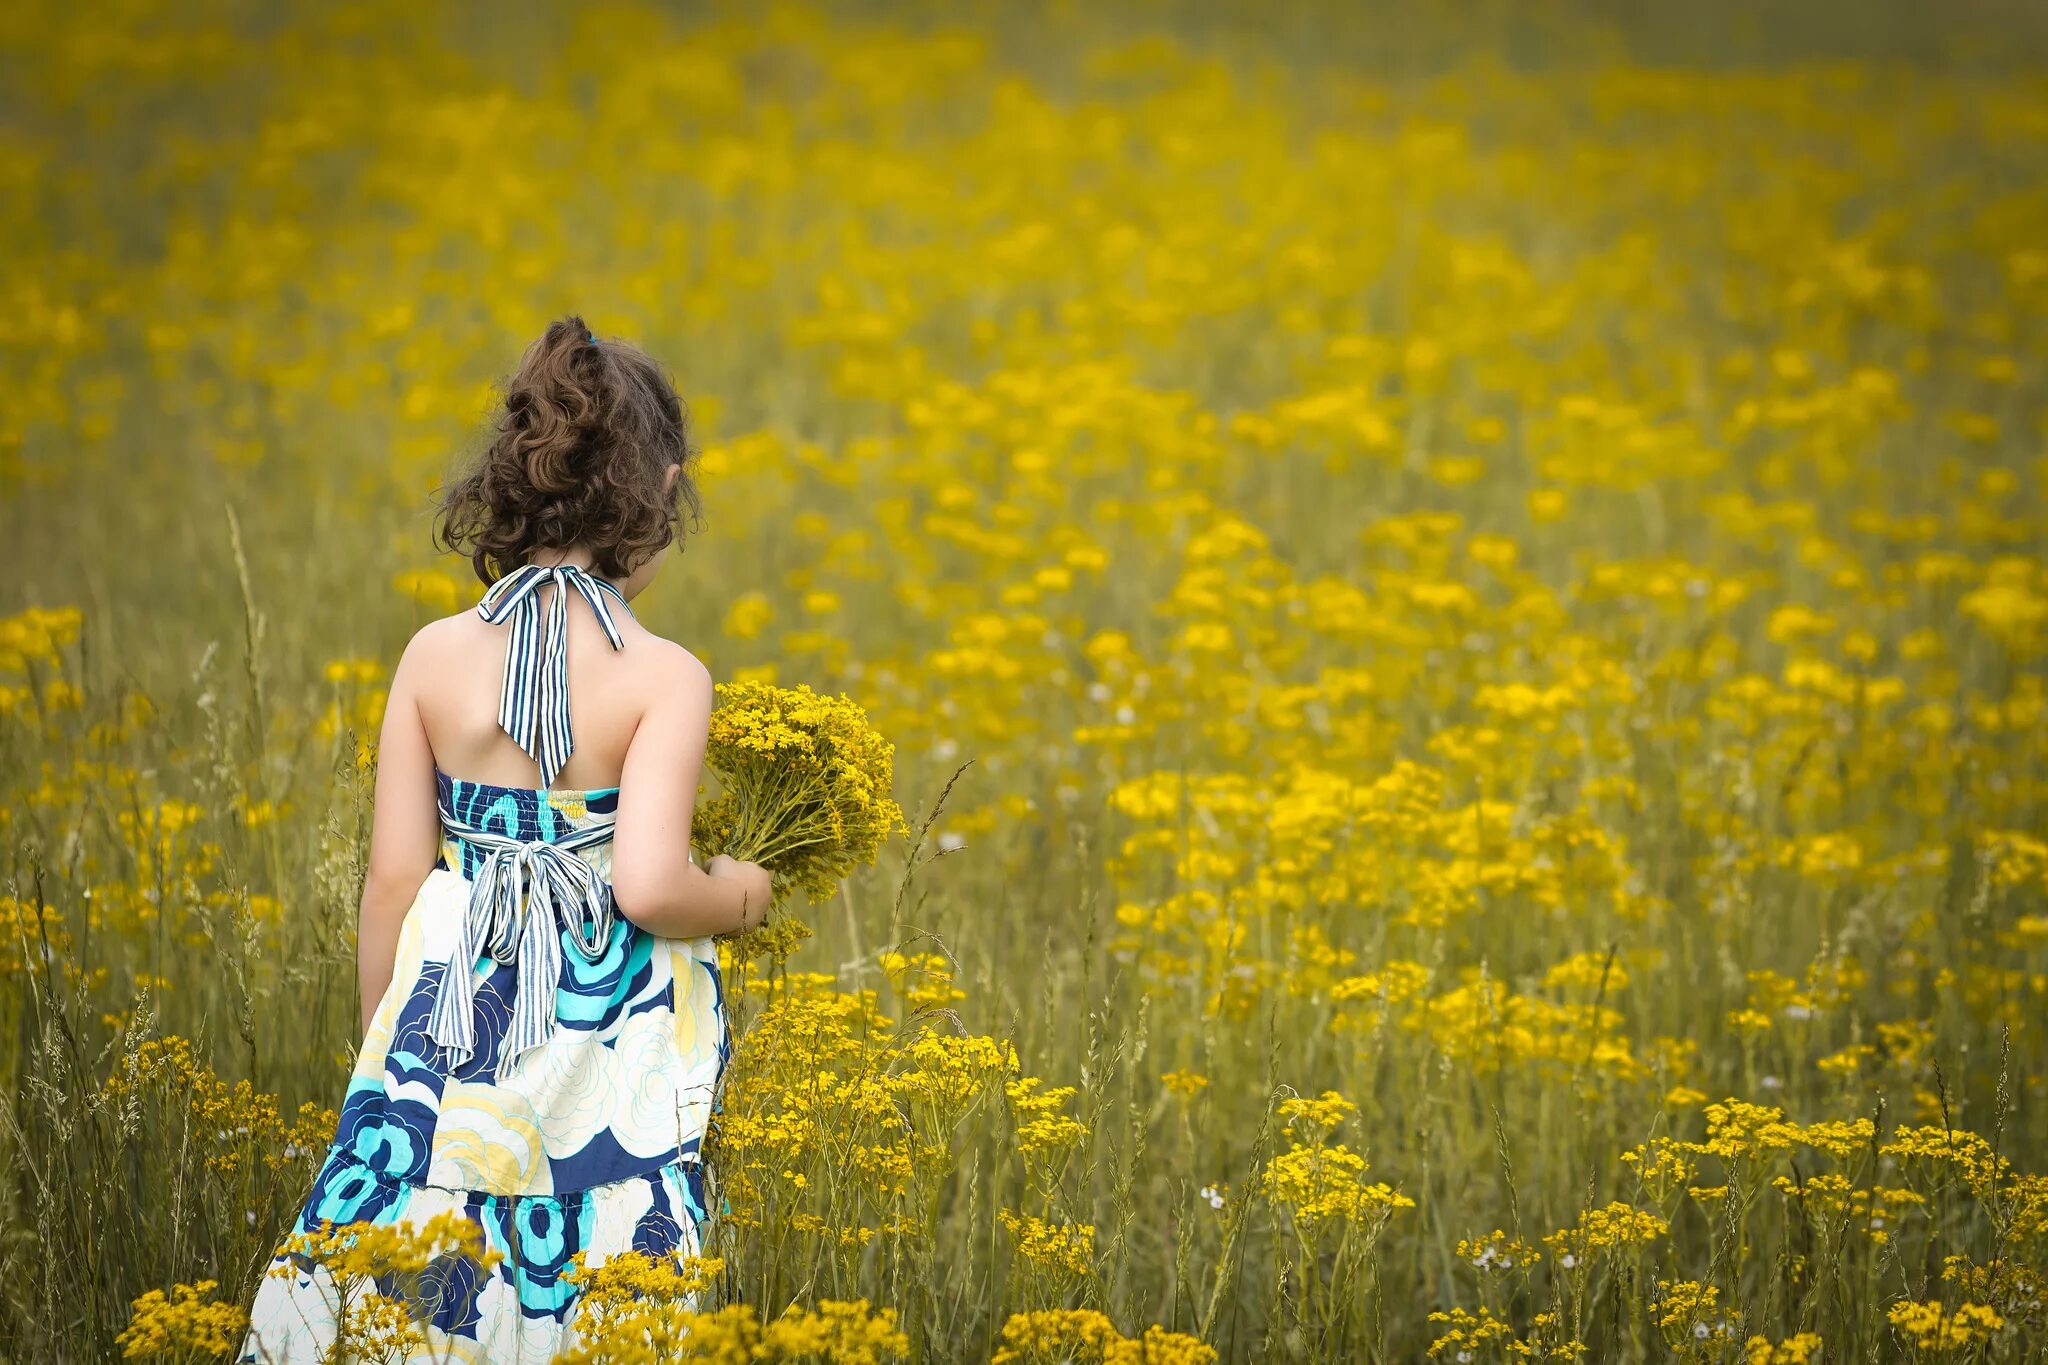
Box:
356;636;440;1029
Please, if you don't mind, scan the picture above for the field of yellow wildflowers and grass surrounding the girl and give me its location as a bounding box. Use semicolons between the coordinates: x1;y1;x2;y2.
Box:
0;0;2048;1365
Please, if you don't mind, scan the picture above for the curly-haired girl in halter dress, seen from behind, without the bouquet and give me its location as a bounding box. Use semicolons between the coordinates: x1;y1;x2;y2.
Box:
244;317;770;1363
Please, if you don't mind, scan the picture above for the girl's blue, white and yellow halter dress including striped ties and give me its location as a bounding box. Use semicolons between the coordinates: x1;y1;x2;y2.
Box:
242;565;729;1365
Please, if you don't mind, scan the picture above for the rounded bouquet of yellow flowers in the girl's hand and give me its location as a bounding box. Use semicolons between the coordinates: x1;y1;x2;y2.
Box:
690;681;903;900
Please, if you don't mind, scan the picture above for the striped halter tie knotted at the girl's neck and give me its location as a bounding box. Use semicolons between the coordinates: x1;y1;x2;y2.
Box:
477;565;633;788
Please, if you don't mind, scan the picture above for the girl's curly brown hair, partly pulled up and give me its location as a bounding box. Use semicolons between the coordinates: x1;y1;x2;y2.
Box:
434;315;700;583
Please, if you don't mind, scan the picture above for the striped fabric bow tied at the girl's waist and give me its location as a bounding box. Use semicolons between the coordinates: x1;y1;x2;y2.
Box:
426;804;618;1078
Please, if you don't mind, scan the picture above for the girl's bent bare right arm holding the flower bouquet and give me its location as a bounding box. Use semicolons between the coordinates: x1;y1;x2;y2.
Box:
612;649;770;939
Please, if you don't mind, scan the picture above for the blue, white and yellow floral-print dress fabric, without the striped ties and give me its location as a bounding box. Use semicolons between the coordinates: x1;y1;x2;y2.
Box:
242;774;729;1363
